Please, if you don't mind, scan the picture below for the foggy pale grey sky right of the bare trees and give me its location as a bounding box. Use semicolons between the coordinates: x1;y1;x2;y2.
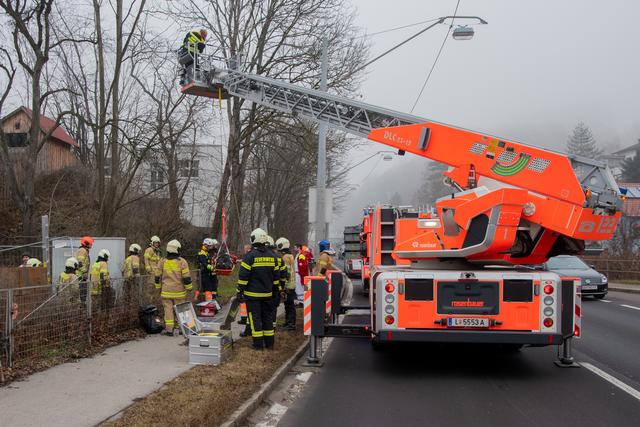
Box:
331;0;640;236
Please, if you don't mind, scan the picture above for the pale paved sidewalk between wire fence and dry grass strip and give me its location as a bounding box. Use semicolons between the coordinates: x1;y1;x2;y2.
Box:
0;335;191;427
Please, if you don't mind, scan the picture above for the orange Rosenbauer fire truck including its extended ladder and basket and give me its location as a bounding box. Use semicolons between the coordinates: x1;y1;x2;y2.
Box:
182;49;623;358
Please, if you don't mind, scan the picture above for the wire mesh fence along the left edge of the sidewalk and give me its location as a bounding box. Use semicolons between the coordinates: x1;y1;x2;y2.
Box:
0;270;199;382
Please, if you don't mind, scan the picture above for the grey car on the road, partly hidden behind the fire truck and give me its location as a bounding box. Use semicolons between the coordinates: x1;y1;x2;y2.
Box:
543;255;609;299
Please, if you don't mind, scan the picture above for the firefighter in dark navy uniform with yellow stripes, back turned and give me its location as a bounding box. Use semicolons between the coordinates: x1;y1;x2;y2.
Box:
237;228;279;350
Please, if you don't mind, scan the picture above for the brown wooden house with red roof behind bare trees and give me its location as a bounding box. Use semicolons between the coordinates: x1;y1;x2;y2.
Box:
1;107;78;175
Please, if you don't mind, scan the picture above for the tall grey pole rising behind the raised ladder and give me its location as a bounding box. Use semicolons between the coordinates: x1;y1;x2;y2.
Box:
313;37;329;248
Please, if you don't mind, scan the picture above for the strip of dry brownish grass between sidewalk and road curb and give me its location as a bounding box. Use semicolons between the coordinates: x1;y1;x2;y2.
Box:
105;317;305;427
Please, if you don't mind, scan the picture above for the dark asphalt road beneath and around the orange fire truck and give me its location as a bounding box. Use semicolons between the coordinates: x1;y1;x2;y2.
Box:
278;282;640;426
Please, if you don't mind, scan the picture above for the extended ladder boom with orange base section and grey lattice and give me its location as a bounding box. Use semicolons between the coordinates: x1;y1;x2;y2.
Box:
182;55;621;219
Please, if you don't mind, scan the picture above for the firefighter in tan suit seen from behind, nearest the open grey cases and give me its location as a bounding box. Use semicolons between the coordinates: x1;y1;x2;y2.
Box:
155;240;193;336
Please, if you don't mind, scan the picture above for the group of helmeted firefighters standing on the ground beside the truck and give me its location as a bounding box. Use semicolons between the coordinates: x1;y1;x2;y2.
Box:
23;228;334;349
